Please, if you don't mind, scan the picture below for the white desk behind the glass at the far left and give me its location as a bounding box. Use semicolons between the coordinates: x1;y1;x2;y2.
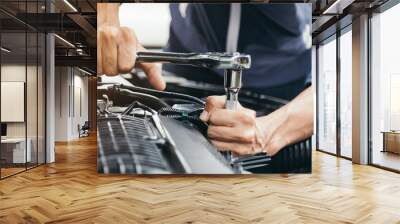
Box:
1;138;32;163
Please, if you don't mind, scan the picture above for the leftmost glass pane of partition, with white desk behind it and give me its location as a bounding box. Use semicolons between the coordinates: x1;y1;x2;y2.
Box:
0;32;27;177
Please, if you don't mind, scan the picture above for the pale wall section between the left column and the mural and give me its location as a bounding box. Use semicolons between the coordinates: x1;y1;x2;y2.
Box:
55;67;89;141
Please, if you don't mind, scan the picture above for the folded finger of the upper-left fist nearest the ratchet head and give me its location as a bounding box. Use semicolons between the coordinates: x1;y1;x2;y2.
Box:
117;27;137;73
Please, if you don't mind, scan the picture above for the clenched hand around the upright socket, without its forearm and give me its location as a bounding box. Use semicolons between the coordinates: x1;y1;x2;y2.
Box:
200;96;265;155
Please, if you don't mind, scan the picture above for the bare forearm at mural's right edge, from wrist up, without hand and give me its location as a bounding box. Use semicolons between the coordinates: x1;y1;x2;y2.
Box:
259;87;314;154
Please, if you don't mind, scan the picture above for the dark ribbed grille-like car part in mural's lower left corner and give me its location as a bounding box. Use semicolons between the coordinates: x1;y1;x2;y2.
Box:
97;115;169;174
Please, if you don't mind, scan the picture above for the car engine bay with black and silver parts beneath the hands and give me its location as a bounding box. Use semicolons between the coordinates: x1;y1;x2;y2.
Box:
97;73;311;174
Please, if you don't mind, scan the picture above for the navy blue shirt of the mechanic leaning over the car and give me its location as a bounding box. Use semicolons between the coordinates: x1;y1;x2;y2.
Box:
164;3;312;99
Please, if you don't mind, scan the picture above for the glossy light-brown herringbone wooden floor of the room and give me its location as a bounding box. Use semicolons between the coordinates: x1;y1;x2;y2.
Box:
0;137;400;223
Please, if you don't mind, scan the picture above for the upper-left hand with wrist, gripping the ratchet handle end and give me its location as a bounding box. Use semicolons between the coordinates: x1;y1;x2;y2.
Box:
97;3;165;90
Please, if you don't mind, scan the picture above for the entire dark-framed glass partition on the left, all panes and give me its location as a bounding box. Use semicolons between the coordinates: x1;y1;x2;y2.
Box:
0;1;46;179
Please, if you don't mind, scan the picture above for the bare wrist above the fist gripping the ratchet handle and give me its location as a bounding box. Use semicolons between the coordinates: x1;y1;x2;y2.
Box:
97;3;121;26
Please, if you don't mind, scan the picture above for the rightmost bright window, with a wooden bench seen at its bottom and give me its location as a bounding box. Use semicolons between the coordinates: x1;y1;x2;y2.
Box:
370;4;400;170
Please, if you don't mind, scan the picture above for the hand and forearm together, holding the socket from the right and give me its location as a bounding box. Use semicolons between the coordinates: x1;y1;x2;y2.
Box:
200;87;314;156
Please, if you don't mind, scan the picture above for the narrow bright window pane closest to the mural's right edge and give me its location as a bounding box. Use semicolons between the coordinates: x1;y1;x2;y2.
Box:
317;36;336;153
